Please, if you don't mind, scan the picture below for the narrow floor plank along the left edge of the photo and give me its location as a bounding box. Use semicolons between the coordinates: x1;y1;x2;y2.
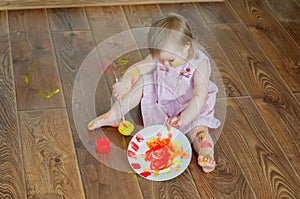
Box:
0;11;26;198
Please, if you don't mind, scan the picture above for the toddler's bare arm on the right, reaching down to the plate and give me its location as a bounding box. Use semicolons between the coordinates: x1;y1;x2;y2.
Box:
167;60;209;127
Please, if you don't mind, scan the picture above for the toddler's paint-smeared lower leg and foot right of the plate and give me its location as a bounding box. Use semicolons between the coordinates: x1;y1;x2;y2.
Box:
187;126;216;173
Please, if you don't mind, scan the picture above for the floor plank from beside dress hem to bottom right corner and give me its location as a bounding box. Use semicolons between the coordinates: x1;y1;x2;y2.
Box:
224;98;300;198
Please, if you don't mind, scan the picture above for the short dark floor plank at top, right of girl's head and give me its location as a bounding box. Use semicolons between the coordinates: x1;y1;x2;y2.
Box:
195;1;239;24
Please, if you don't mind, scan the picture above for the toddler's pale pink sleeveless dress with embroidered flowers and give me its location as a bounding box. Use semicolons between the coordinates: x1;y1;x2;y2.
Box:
141;51;220;133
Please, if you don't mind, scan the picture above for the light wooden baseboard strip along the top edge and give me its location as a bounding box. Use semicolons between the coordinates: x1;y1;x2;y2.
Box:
0;0;224;10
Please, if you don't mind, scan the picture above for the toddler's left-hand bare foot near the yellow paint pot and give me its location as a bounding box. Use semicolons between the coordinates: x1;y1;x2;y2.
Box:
88;113;119;131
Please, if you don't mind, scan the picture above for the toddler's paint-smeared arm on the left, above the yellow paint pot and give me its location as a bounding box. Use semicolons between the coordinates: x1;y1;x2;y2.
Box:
113;55;156;99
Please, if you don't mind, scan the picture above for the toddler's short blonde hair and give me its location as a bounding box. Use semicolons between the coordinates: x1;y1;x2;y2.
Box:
148;13;193;56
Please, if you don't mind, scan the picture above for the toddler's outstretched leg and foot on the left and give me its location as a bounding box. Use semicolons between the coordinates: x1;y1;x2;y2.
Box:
88;77;143;131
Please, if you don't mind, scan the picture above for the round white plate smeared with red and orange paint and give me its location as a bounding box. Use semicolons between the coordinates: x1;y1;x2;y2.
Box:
127;125;192;181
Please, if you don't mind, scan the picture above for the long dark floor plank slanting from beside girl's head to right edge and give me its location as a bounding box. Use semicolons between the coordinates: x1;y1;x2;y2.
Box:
210;24;300;173
